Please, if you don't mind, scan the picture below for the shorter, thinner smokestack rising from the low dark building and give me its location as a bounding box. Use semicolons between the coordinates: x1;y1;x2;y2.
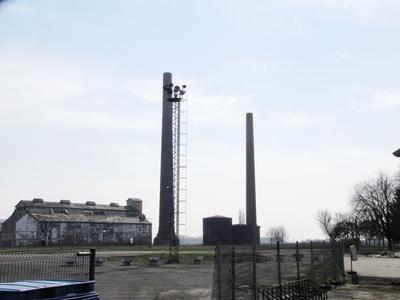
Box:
246;113;257;226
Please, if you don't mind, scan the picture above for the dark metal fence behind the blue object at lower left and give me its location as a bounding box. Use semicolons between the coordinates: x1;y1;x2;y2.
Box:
0;249;96;283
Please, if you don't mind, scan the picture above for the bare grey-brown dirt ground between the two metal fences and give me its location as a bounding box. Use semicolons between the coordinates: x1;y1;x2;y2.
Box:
96;261;213;300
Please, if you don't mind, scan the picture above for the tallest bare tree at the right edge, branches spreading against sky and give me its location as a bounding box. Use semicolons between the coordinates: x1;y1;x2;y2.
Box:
352;173;397;251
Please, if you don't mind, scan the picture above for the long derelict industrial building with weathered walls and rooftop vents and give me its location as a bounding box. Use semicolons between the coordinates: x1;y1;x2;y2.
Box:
0;198;152;247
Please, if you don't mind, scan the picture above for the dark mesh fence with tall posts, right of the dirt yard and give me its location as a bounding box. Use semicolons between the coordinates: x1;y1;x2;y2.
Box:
212;243;344;300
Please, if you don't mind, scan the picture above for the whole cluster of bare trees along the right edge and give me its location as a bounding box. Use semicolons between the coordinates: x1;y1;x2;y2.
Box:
317;172;400;251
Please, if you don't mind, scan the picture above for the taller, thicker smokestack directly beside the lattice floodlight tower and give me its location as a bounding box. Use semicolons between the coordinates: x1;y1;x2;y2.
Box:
154;73;177;245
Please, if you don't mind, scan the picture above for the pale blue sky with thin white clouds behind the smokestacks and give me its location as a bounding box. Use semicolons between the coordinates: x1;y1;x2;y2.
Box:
0;0;400;240
